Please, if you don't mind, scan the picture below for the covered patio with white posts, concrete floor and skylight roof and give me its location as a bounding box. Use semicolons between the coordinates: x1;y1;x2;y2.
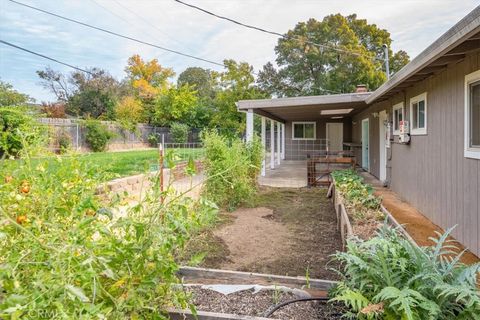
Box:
237;90;370;187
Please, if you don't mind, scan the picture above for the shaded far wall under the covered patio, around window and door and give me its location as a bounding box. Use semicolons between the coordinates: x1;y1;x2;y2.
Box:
282;118;352;160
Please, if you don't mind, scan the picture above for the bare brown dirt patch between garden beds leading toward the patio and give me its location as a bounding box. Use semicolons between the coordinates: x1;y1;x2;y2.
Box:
182;188;341;279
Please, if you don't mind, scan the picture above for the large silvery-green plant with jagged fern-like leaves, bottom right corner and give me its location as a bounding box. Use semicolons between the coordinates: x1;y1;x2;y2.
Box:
332;226;480;320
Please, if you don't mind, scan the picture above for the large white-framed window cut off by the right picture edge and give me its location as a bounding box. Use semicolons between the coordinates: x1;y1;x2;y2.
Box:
465;70;480;159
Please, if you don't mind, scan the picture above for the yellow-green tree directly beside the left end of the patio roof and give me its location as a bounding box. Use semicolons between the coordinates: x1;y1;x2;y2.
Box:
210;60;267;135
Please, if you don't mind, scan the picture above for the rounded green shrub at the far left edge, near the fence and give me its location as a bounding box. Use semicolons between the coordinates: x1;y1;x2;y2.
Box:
0;107;45;157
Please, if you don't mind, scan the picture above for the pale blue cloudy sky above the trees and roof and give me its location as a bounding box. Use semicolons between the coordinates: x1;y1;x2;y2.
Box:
0;0;479;102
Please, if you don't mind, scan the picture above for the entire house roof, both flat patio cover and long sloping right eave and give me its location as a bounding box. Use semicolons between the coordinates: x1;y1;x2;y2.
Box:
237;6;480;117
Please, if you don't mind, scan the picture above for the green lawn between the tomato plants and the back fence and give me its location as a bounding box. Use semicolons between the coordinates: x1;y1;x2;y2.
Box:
7;149;203;180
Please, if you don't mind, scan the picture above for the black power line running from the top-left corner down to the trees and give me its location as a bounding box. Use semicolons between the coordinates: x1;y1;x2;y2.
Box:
8;0;225;67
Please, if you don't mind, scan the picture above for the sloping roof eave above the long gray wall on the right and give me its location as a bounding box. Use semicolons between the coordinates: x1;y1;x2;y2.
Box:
367;6;480;104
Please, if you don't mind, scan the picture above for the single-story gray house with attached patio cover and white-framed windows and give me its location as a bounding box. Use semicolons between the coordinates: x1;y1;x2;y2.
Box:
237;7;480;256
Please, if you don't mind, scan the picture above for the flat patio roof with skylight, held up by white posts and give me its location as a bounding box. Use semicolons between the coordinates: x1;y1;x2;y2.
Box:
237;92;371;122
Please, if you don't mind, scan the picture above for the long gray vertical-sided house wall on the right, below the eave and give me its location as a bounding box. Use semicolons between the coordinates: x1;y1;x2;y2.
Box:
352;52;480;255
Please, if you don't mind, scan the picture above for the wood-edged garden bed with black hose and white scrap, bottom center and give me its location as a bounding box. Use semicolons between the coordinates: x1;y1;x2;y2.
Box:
170;267;345;320
